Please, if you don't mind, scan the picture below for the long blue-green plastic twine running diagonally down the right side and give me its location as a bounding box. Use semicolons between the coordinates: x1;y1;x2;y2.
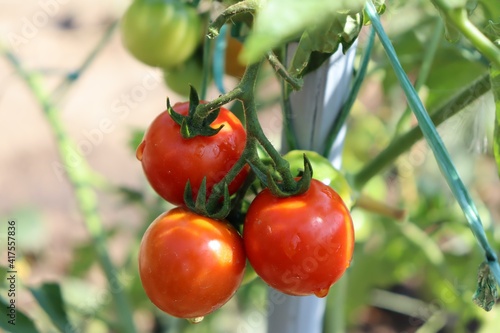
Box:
365;0;500;285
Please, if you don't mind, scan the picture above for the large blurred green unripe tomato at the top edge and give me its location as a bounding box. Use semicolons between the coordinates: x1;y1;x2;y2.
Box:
120;0;202;68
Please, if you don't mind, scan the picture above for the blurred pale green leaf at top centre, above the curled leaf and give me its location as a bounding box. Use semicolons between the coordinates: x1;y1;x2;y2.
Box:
241;0;364;63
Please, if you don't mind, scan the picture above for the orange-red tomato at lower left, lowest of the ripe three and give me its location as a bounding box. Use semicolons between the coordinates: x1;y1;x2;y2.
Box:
139;208;246;318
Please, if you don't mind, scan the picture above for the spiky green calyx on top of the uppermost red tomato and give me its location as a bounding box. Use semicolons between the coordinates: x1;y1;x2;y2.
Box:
167;86;224;139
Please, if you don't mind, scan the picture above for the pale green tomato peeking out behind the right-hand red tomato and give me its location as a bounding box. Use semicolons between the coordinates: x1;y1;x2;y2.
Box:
283;150;354;208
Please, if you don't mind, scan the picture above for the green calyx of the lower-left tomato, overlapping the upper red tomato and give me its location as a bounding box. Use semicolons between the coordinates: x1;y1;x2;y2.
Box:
184;177;231;220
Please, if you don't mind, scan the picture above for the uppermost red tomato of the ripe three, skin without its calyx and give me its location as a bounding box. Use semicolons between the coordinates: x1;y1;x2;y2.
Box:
136;101;249;206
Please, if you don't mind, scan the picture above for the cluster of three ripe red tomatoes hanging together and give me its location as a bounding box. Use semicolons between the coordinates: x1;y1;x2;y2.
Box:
137;101;354;319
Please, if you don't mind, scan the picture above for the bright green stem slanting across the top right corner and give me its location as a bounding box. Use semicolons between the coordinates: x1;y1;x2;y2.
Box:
432;0;500;67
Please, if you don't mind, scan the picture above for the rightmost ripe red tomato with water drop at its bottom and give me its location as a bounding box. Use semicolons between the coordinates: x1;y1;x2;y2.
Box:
243;179;354;297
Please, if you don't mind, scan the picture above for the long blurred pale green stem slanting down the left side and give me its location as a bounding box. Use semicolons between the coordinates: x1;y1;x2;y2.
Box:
6;52;136;333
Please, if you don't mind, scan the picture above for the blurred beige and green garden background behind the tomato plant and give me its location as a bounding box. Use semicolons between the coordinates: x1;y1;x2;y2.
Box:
0;0;500;332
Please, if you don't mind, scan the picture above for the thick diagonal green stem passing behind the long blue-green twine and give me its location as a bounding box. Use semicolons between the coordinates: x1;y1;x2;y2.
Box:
351;74;491;190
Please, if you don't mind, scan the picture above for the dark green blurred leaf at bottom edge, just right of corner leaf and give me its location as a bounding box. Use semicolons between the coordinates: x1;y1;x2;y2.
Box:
29;283;72;332
